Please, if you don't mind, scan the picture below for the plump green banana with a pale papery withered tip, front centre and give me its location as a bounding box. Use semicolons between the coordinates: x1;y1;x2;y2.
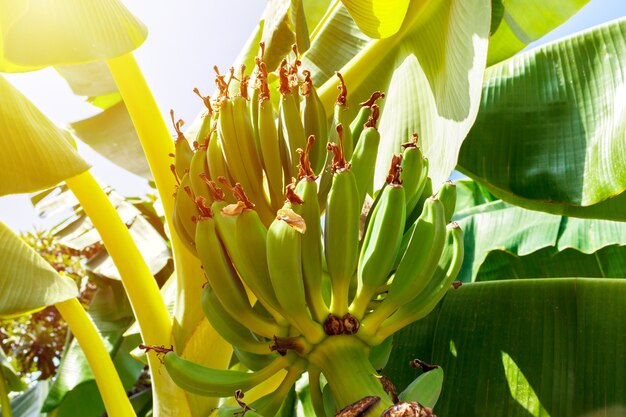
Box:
267;204;325;344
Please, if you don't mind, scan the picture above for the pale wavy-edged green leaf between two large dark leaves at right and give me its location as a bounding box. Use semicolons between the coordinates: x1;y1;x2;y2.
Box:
455;193;626;282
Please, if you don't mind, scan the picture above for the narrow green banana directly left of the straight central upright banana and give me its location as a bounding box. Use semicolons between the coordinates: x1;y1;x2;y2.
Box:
294;136;330;323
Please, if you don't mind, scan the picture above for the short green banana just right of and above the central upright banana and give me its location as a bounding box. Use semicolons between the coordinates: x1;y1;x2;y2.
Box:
350;104;380;207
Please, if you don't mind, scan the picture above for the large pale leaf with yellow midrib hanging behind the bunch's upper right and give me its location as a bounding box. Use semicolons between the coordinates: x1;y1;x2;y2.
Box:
302;0;490;189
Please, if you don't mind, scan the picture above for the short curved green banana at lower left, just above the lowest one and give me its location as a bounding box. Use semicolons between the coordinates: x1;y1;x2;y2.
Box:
200;284;272;355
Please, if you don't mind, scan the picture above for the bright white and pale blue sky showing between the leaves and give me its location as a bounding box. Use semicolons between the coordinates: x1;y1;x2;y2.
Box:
0;0;626;231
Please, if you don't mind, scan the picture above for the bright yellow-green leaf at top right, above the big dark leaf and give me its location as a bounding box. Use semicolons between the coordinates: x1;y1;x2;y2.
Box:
487;0;589;66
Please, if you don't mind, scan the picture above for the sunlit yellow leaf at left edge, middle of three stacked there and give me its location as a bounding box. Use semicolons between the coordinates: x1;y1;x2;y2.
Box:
0;77;89;195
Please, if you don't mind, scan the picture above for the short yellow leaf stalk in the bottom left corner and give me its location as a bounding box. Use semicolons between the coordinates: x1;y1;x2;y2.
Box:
55;298;135;417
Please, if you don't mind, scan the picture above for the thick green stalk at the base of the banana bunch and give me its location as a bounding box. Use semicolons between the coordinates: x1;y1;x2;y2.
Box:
309;335;393;416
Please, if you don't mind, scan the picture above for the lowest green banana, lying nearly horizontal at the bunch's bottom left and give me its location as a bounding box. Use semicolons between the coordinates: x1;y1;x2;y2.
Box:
163;351;294;397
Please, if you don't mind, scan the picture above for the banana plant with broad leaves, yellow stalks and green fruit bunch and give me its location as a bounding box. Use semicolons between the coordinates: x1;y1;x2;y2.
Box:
0;0;626;416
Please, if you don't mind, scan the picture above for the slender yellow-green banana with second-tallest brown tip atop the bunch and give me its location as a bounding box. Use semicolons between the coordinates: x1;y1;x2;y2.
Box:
257;59;284;209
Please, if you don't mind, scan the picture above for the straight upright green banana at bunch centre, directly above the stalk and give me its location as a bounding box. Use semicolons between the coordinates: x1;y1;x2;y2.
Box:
324;125;361;317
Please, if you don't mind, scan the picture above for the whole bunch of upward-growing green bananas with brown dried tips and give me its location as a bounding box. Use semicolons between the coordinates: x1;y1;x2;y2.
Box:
164;44;463;417
